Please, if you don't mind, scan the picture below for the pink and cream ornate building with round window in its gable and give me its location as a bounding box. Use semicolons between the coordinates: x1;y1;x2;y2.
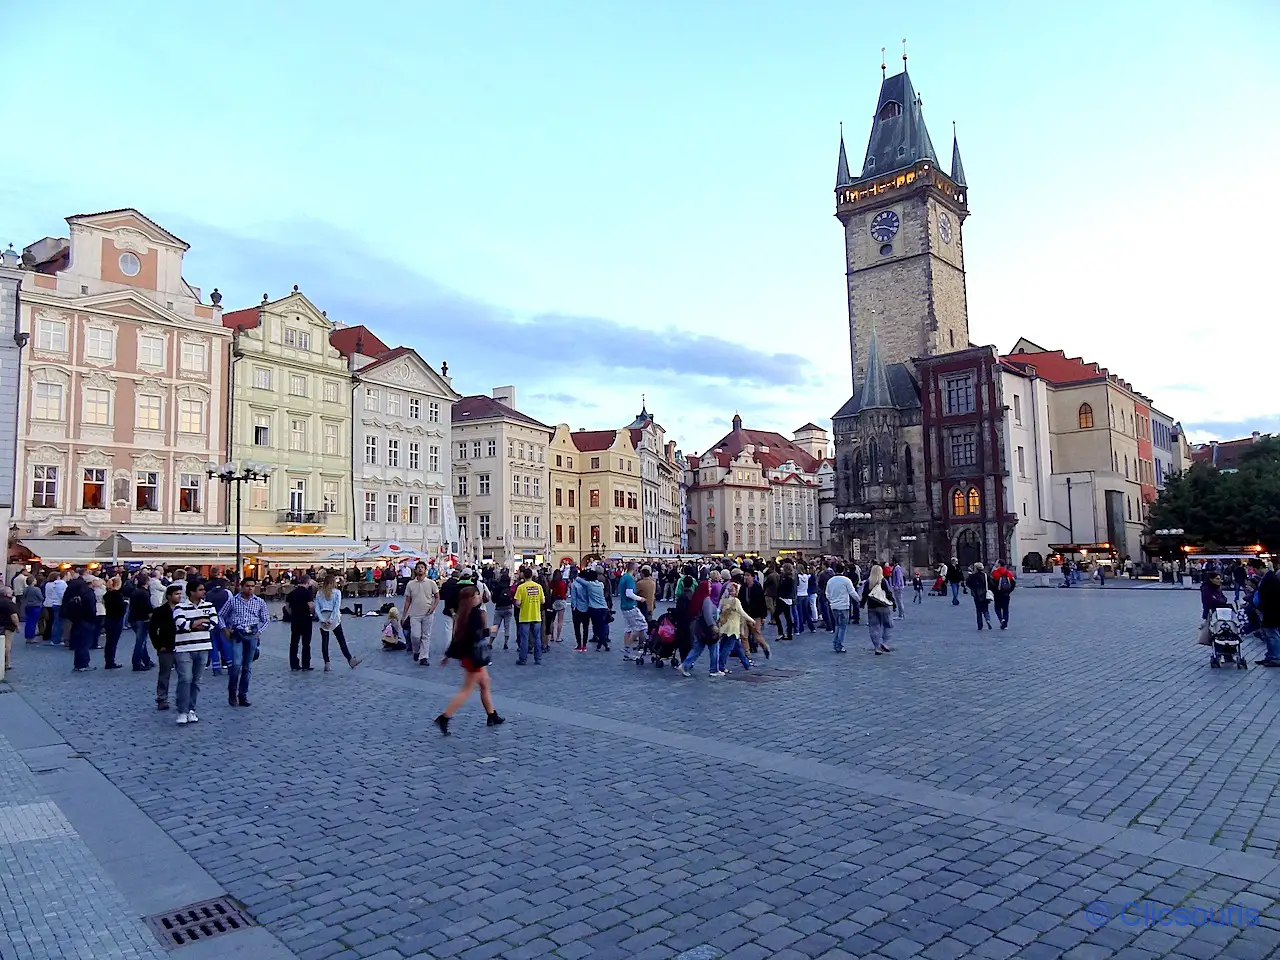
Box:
14;209;232;562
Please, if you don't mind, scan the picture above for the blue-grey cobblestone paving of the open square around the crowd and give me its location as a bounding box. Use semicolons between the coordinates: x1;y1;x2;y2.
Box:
0;590;1280;960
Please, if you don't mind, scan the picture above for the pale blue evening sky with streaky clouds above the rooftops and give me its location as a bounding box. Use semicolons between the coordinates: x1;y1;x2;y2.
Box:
0;0;1280;452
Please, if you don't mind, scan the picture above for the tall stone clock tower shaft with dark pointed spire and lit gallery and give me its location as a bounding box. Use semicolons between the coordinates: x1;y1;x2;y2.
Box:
836;55;969;393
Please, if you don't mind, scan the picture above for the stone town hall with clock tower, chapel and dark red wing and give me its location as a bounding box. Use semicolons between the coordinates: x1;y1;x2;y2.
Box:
832;58;1016;566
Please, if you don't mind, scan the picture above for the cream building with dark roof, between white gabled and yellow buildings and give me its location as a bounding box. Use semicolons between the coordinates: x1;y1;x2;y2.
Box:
447;387;554;566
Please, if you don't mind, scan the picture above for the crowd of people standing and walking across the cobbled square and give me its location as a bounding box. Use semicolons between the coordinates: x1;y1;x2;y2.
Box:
37;547;1280;733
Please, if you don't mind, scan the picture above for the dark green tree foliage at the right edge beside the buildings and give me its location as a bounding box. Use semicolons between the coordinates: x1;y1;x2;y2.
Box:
1148;438;1280;552
